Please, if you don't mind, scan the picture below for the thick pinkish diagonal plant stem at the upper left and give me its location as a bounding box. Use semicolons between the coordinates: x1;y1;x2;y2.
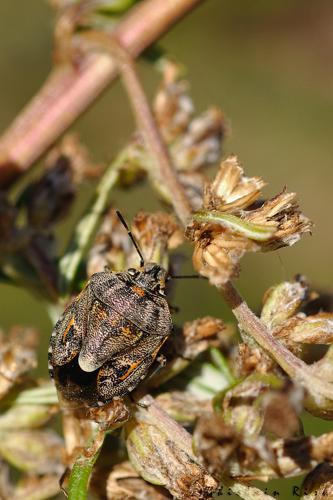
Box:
0;0;204;185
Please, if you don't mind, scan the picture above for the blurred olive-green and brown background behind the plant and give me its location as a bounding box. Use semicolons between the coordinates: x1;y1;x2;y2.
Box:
0;0;333;498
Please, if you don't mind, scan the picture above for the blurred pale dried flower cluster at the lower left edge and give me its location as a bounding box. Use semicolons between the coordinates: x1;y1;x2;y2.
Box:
0;327;64;500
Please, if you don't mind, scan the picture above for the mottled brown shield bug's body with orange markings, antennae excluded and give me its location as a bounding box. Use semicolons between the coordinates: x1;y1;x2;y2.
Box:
49;263;172;405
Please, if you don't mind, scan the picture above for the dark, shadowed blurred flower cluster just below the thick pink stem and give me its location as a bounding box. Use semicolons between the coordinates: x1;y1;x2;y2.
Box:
0;135;101;302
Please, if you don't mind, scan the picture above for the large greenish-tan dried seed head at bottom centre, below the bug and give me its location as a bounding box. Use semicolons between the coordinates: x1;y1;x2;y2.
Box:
125;403;218;500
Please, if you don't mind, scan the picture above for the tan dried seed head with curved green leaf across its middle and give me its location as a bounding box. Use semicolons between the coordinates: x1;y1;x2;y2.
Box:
186;156;312;286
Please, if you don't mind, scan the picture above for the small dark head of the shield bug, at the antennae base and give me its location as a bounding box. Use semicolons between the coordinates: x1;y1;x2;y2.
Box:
127;262;168;296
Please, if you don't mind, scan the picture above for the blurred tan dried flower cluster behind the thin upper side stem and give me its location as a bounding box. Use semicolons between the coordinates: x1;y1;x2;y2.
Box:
114;59;226;209
